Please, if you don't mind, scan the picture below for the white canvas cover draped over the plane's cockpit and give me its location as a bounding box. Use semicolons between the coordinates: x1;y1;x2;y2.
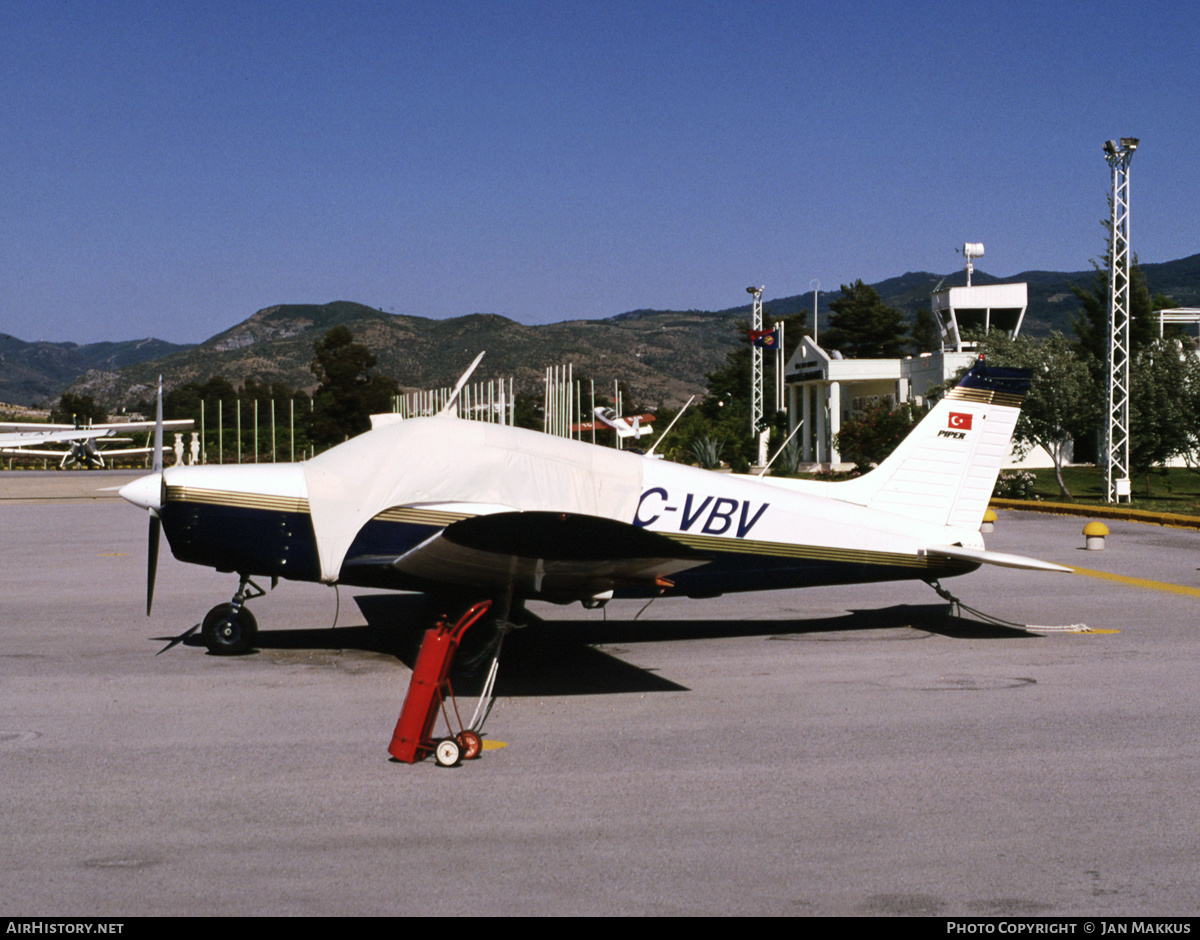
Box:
304;415;643;582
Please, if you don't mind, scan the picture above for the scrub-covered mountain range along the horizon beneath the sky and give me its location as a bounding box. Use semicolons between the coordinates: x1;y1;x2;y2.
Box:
0;255;1200;411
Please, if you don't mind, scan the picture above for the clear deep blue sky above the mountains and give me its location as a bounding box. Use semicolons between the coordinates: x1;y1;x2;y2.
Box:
0;0;1200;342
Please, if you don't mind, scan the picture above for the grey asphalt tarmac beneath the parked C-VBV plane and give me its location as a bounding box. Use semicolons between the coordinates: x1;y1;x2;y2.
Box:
0;473;1200;918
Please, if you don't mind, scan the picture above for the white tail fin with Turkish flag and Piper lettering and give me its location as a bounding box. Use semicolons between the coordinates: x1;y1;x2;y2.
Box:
834;357;1030;528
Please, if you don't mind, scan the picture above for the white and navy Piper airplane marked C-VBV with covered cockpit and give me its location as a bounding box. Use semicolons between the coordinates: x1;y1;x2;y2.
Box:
120;359;1070;653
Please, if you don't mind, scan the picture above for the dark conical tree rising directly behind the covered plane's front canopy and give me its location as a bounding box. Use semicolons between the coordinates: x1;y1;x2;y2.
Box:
310;325;400;447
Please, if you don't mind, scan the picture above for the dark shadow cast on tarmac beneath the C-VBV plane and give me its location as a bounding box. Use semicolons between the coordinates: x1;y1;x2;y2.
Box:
174;594;1033;696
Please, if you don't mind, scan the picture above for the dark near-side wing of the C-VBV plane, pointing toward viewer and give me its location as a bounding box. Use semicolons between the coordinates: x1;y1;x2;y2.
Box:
347;513;708;599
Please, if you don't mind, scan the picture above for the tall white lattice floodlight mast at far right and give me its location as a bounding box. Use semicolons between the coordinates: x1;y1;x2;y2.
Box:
1104;137;1138;503
